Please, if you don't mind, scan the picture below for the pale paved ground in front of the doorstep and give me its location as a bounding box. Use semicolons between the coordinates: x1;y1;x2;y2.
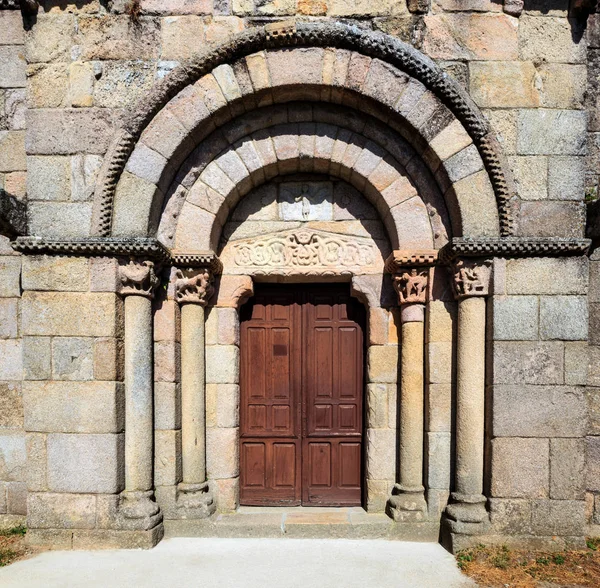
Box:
0;538;475;588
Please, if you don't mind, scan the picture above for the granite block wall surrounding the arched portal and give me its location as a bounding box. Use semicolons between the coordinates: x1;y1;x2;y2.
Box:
0;0;600;547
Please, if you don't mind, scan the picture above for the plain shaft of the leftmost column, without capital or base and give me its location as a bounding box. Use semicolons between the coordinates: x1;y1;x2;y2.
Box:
125;295;153;492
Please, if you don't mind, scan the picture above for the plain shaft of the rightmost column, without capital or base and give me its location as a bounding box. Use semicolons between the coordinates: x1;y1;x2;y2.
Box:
456;296;486;496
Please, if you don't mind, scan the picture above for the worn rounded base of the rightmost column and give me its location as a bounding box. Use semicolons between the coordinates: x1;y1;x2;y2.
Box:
442;492;490;553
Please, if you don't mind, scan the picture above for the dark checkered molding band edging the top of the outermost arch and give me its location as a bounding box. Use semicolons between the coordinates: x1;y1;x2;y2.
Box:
96;22;514;236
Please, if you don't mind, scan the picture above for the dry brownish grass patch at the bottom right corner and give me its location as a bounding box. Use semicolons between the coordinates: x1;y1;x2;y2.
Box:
456;537;600;588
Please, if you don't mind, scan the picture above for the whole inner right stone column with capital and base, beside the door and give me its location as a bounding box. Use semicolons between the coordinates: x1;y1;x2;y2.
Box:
388;267;429;521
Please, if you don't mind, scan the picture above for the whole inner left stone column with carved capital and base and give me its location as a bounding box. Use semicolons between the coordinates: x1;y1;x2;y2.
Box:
175;267;215;517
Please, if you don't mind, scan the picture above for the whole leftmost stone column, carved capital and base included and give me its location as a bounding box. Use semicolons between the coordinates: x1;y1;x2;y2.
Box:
119;259;160;528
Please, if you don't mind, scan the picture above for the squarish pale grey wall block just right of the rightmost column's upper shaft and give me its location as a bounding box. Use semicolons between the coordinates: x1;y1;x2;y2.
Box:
493;296;539;341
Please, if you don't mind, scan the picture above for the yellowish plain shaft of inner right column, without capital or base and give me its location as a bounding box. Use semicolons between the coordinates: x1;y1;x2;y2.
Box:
400;305;424;492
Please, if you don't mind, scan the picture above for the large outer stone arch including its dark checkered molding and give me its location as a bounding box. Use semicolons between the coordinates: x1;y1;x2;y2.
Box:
95;23;513;237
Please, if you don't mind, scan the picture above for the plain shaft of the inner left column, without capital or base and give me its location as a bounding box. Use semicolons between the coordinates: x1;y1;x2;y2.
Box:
181;304;206;484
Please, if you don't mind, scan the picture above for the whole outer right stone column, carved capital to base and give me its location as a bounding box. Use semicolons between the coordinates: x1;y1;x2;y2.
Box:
446;260;491;534
